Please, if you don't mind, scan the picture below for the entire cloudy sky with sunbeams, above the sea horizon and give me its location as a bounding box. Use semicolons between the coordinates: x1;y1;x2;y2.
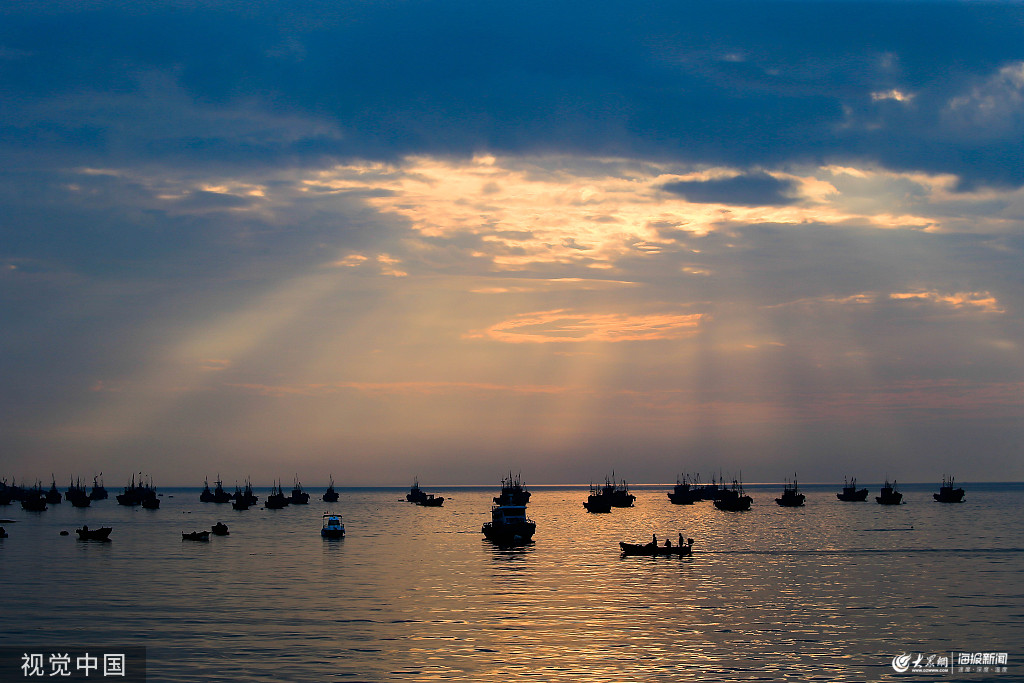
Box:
0;0;1024;486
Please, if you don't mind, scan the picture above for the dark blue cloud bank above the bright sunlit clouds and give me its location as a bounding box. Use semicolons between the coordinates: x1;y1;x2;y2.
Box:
0;1;1024;185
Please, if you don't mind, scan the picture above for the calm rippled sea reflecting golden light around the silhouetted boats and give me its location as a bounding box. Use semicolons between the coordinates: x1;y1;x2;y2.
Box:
0;484;1024;682
